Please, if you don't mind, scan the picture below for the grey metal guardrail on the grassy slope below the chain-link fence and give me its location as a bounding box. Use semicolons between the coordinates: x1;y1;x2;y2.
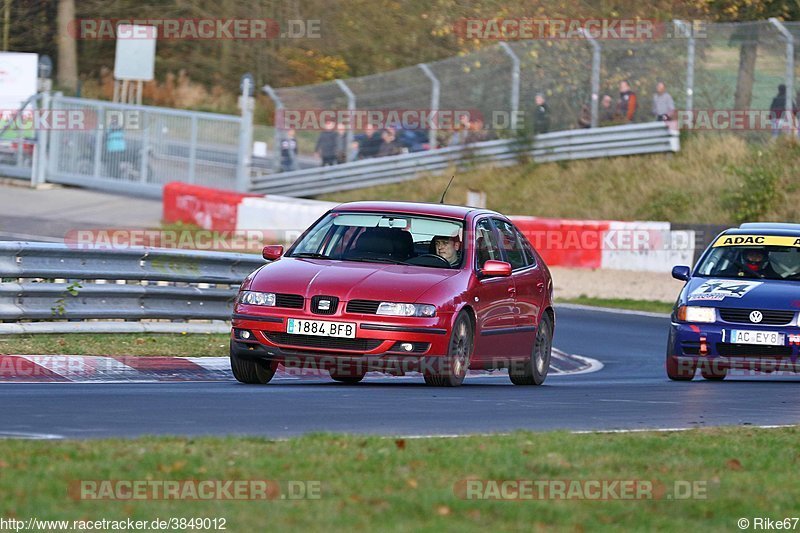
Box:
251;122;680;197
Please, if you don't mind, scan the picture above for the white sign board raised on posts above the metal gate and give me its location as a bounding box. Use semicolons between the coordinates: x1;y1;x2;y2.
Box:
114;24;158;81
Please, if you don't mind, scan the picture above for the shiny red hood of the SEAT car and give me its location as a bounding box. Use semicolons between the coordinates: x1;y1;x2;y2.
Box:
250;257;459;304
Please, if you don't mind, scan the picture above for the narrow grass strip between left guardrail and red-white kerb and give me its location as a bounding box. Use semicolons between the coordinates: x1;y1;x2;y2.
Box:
0;333;229;358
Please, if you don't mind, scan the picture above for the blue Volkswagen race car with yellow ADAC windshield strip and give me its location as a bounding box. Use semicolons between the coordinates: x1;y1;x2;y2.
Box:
666;223;800;381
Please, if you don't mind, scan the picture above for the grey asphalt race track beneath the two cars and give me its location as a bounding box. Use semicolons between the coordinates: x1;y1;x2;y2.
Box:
0;308;800;438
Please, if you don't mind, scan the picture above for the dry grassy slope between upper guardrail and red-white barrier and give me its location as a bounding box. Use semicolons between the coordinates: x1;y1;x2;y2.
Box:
321;133;800;224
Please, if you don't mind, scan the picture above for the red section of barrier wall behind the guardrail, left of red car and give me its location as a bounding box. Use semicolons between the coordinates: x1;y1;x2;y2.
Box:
163;181;254;231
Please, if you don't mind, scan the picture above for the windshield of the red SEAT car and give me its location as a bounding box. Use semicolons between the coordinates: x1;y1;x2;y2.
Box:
287;213;464;268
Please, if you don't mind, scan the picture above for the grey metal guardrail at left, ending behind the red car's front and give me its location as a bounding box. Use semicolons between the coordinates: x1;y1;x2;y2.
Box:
0;242;264;334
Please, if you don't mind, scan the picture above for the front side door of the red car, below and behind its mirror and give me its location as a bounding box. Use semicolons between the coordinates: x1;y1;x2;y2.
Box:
473;217;519;360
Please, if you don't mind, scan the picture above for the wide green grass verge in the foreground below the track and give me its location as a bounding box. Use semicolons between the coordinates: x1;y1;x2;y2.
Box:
0;428;800;531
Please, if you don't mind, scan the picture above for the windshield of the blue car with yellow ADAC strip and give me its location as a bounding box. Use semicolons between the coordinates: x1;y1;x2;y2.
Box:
697;235;800;280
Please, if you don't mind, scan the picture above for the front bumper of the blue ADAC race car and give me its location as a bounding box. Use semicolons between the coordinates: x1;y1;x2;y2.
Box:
667;321;800;372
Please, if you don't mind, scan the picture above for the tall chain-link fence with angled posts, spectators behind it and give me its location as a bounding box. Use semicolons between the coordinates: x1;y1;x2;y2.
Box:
272;19;800;168
